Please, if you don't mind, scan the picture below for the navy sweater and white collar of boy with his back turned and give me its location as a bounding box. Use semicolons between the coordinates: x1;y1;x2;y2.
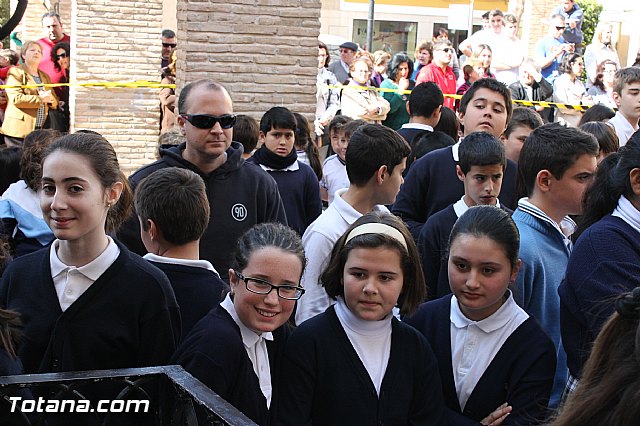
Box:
144;253;229;337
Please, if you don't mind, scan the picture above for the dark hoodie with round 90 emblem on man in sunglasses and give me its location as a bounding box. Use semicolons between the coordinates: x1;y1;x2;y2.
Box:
117;142;287;271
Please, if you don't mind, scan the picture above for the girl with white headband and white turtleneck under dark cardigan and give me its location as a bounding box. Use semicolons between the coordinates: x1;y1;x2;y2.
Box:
274;213;446;425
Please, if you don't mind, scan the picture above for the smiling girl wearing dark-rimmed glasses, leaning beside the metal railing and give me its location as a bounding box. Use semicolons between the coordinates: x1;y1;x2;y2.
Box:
174;223;306;425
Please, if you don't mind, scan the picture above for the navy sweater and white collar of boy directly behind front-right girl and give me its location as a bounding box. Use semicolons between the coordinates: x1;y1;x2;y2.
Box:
418;199;513;300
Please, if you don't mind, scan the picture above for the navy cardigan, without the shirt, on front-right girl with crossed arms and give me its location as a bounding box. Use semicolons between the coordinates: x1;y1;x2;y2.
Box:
406;296;556;425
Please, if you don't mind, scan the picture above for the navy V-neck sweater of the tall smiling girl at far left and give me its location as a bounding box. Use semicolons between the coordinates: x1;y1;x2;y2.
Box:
0;242;180;374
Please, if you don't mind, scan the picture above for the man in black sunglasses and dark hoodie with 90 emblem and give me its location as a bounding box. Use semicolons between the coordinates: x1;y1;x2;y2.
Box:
117;80;287;271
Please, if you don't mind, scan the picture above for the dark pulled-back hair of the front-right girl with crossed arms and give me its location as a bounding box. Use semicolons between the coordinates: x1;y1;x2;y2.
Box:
448;206;520;268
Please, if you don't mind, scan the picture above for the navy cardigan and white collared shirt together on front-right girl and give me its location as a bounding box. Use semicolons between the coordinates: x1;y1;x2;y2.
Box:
405;295;556;425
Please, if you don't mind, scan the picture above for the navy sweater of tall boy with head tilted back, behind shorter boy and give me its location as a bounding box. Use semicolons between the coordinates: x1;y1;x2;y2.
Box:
391;147;517;241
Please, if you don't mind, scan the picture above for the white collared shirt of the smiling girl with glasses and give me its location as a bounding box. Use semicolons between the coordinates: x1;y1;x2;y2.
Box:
220;294;273;407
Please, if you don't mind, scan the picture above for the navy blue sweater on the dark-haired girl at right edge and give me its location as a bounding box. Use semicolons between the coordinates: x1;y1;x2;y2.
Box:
558;215;640;377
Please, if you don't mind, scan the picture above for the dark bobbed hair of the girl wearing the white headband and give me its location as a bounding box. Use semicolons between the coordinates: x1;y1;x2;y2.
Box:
320;212;427;315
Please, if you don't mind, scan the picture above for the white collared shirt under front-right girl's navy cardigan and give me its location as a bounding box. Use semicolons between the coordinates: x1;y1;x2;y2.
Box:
449;290;529;411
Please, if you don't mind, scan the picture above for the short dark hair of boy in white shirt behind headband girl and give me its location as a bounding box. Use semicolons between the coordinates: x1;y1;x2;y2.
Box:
346;124;411;186
